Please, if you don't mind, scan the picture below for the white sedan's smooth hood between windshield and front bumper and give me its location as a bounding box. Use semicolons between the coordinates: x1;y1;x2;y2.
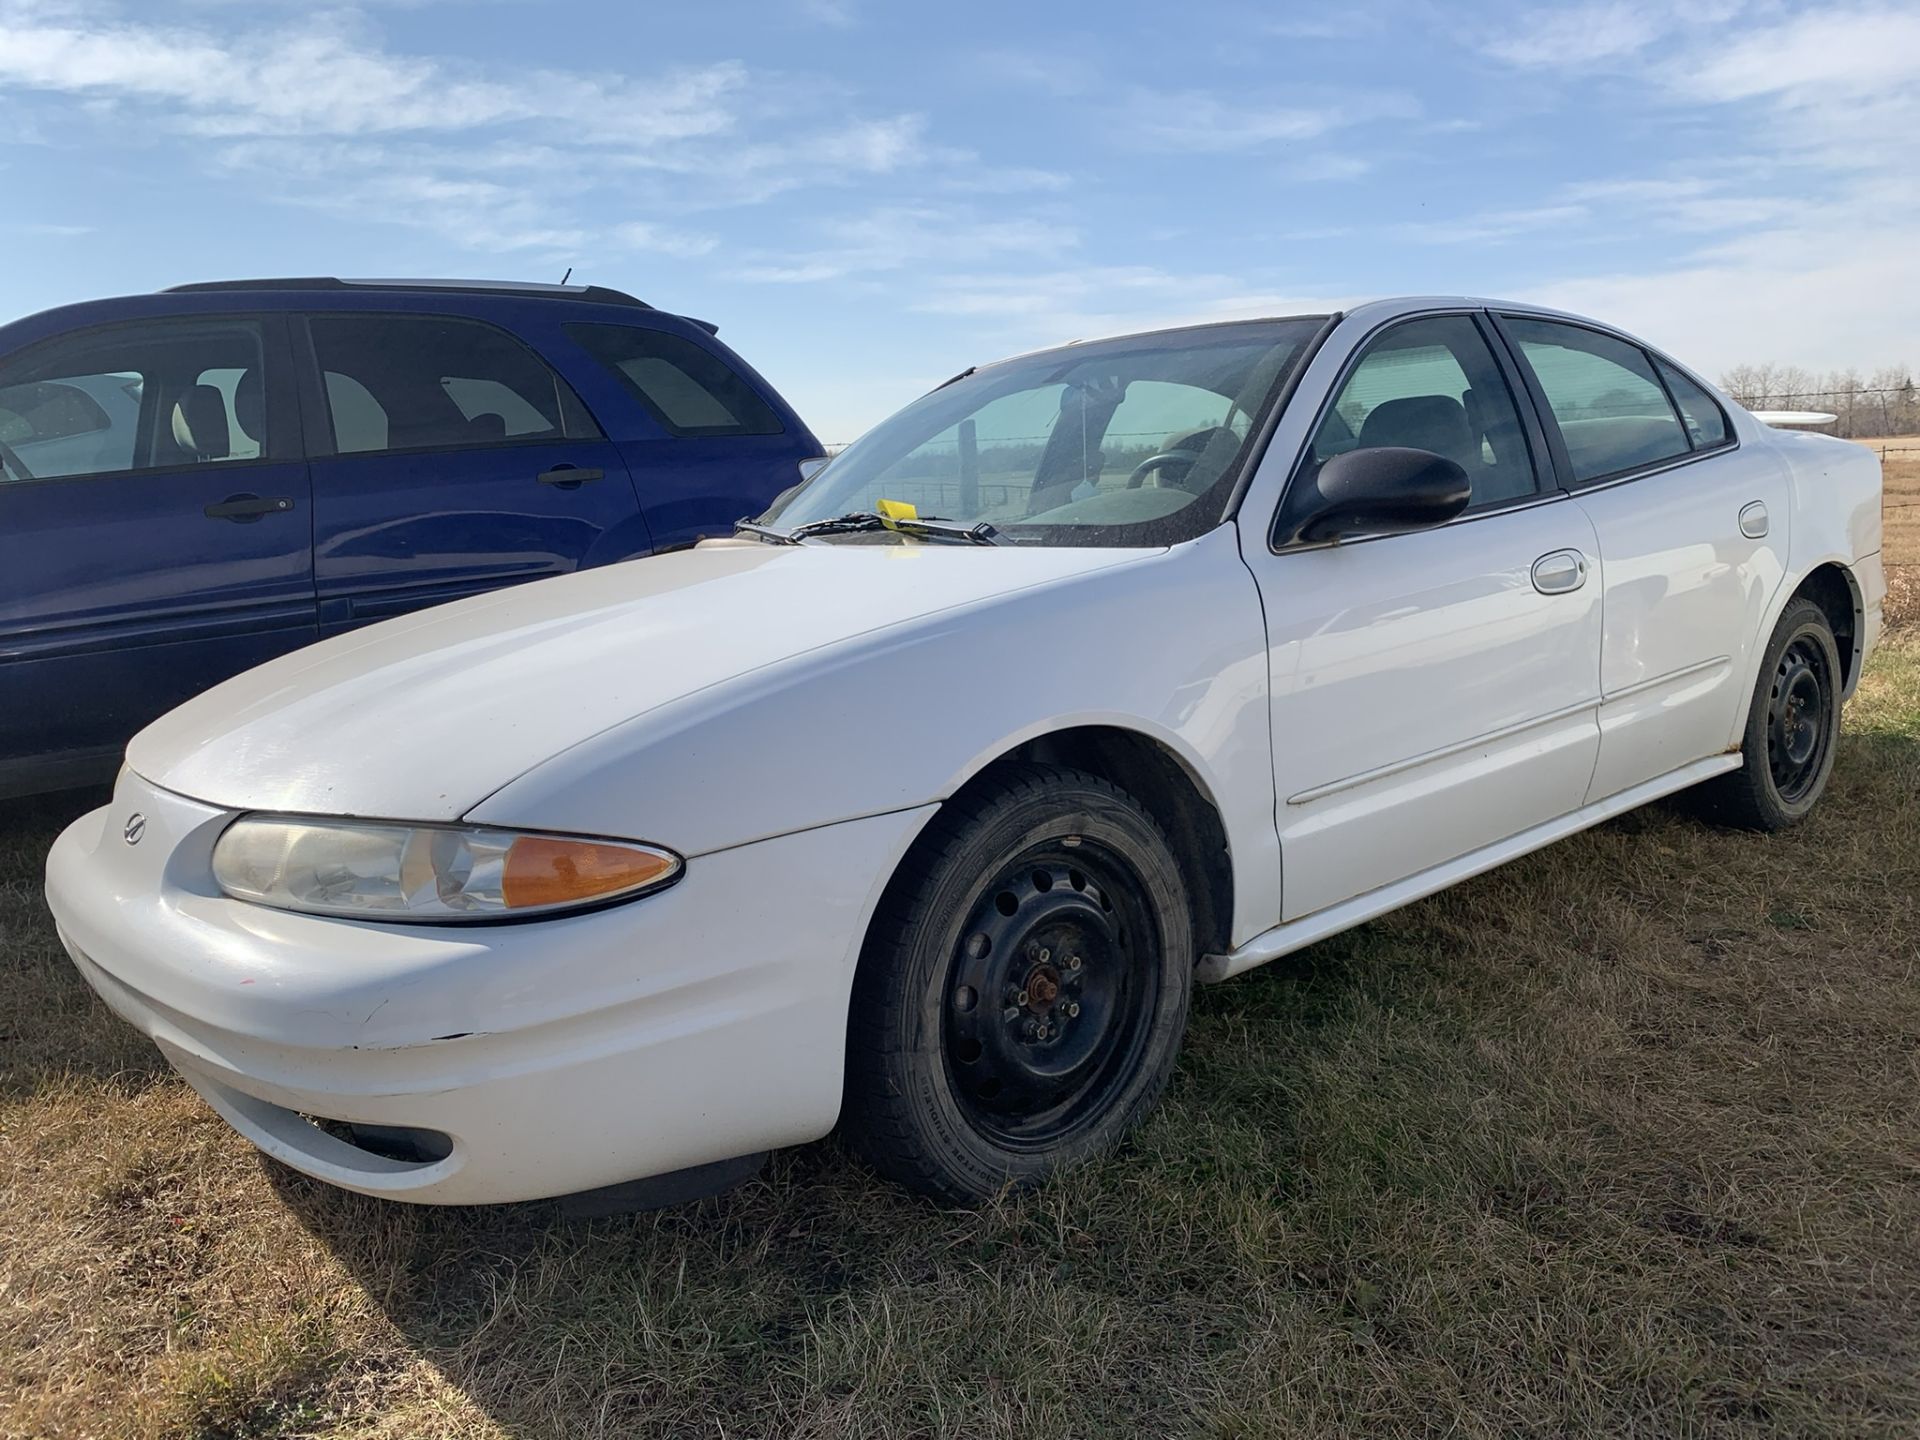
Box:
139;541;1150;820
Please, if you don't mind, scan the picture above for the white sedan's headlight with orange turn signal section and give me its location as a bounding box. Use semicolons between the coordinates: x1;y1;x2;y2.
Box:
213;816;682;922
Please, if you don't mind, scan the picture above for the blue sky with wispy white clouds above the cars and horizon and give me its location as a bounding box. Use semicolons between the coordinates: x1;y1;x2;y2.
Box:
0;0;1920;440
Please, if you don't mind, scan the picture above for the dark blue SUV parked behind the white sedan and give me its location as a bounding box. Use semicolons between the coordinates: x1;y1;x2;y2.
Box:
0;278;820;797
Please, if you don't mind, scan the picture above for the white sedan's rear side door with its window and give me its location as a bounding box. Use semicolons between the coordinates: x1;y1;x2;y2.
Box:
1500;315;1789;801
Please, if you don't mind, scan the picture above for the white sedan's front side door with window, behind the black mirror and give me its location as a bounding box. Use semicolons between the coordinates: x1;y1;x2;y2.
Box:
1242;313;1599;920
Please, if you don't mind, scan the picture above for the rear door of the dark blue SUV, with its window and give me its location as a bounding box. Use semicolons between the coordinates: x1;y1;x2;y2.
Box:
305;311;653;634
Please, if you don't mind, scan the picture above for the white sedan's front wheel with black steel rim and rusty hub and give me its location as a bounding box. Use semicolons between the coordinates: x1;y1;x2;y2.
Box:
843;764;1196;1204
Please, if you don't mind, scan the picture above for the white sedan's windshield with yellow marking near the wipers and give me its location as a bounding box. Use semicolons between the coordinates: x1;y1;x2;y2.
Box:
760;317;1321;547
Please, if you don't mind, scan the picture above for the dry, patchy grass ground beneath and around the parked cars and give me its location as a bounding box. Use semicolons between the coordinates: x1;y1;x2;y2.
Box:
0;453;1920;1440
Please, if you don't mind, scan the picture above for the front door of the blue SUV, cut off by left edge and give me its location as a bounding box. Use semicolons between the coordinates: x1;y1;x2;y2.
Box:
0;315;315;793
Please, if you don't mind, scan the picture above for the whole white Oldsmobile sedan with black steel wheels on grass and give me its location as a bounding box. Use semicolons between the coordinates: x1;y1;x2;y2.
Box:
46;300;1885;1202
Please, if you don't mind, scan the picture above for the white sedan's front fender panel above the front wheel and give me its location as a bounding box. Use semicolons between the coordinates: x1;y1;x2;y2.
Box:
468;526;1279;948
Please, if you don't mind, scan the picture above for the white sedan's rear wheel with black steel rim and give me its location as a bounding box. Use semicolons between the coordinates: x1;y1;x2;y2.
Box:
1699;599;1841;831
